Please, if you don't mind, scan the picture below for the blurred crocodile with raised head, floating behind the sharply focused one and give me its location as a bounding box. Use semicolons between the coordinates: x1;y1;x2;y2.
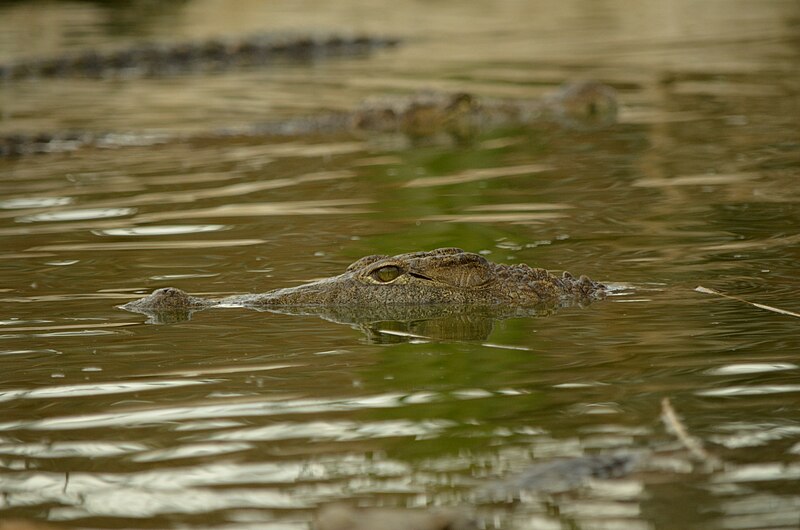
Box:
0;81;618;157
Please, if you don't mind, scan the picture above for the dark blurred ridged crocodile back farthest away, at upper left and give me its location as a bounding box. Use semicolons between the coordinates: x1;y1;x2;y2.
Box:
0;34;400;81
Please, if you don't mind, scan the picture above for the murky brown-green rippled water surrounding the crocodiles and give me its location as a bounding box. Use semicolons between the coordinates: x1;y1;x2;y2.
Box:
0;0;800;530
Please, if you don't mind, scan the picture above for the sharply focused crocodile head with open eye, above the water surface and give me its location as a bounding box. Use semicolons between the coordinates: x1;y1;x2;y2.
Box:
121;247;606;320
